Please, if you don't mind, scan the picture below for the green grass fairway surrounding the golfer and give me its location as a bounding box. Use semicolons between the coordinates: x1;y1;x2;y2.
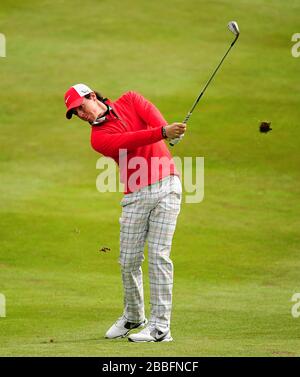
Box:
0;0;300;357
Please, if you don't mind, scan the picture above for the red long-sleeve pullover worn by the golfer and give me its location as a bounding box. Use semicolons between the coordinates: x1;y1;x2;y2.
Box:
91;91;179;194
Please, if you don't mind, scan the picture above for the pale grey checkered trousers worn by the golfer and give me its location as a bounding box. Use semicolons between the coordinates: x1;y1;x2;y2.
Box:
119;175;182;328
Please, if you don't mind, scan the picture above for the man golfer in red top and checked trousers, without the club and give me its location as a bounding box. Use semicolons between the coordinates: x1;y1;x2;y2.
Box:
65;84;186;342
